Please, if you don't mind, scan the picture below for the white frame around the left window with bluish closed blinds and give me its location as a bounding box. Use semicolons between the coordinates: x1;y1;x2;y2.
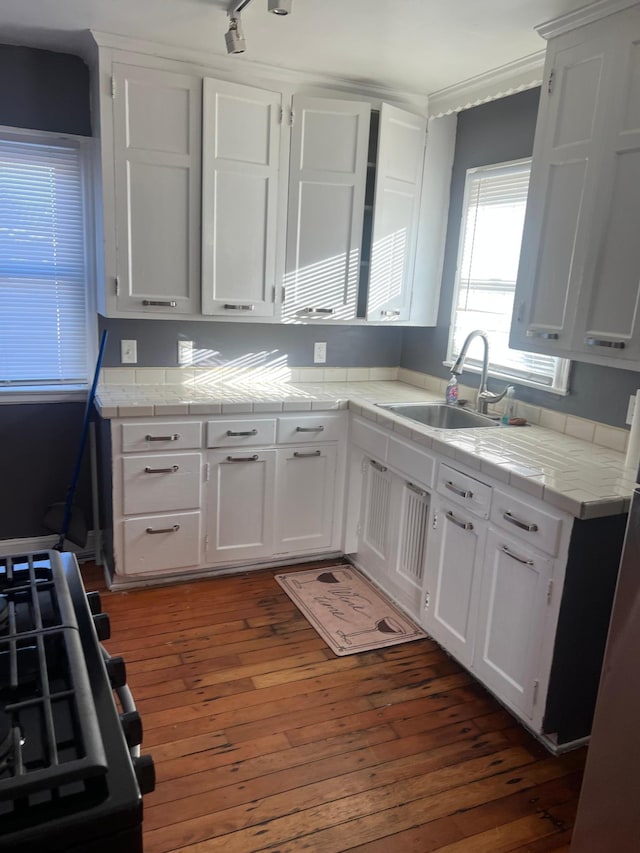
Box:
0;125;98;405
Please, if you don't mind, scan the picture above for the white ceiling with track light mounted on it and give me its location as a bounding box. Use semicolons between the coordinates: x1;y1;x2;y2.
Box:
0;0;586;94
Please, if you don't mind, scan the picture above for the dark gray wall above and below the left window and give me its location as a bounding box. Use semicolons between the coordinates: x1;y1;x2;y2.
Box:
0;45;91;539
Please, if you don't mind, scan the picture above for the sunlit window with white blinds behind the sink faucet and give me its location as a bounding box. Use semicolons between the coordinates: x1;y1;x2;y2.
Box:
447;160;569;393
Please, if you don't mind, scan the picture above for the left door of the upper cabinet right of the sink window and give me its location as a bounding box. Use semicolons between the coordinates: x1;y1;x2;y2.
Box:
510;28;611;355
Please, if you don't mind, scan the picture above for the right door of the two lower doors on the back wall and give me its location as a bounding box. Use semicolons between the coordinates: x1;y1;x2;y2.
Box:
276;445;337;554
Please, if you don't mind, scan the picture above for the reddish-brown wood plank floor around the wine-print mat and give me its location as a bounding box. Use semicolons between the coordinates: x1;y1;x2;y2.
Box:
83;561;585;853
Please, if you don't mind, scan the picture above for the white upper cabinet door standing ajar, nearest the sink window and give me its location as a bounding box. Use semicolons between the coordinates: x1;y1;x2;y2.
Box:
367;104;427;320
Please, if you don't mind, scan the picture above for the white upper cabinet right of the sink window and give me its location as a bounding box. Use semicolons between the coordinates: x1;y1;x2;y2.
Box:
510;6;640;370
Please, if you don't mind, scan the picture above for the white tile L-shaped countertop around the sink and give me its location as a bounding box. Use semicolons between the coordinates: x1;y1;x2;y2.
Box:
96;381;636;519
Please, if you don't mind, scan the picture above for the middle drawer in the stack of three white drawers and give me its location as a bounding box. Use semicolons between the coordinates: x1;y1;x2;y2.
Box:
122;453;202;515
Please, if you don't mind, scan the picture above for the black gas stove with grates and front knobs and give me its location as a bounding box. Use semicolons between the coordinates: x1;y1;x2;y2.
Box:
0;551;155;853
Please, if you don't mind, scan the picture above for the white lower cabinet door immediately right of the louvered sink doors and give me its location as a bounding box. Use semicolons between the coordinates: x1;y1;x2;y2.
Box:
423;498;486;666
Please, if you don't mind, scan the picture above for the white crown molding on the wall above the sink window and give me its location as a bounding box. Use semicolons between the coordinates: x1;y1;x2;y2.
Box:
429;50;545;118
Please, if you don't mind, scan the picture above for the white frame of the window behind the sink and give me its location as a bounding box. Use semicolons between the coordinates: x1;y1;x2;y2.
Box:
443;157;571;396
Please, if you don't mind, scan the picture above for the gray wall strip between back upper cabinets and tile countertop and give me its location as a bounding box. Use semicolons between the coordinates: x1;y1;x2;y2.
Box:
99;317;402;367
